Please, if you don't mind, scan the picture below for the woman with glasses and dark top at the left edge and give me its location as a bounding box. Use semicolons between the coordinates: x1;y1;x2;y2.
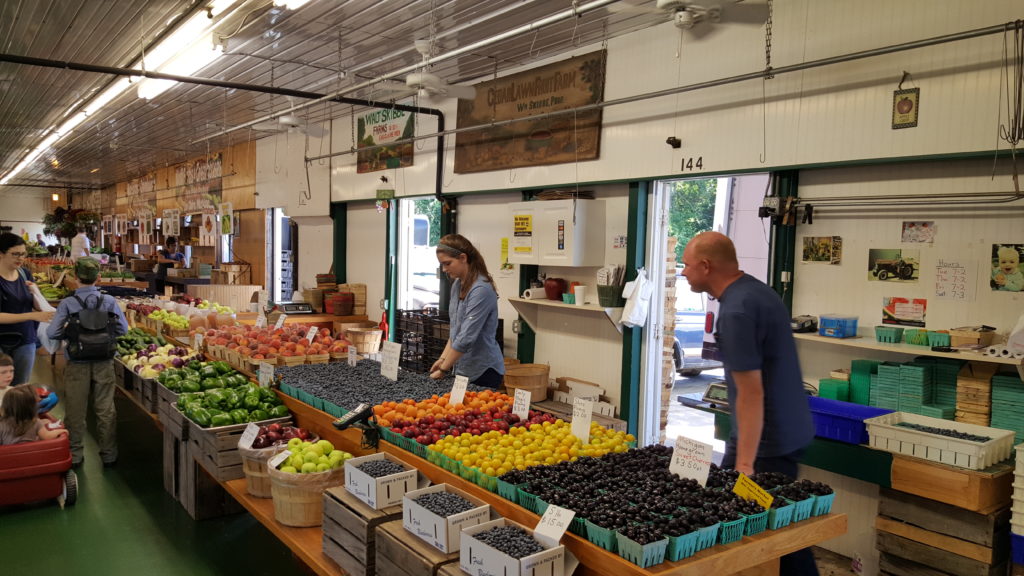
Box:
0;232;53;385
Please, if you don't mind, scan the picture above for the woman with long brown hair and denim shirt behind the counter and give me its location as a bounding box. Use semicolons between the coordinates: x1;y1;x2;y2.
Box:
430;234;505;388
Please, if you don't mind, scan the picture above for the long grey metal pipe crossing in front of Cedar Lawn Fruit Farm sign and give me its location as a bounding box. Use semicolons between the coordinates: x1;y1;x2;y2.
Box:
306;20;1024;162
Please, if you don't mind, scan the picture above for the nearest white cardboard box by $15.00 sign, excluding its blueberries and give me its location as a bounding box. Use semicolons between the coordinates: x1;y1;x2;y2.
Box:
459;518;565;576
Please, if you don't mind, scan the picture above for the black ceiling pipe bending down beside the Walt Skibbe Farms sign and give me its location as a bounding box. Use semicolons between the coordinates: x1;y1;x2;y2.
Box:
0;50;444;200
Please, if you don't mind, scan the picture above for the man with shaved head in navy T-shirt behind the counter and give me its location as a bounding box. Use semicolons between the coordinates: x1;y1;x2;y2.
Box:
683;232;818;576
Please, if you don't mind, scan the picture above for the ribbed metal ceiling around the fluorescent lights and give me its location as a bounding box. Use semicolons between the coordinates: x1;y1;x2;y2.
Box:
0;0;670;195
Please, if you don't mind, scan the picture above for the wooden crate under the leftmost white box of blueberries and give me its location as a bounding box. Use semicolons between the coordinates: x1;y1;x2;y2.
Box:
324;486;401;576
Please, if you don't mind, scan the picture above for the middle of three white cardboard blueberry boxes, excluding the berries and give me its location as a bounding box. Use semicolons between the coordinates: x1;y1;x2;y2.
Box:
401;484;490;553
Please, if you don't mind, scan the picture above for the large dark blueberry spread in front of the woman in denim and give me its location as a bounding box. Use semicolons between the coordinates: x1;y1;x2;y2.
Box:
274;360;482;411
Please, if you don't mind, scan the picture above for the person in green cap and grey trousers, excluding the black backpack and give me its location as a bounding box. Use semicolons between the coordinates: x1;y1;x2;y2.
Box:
46;257;128;466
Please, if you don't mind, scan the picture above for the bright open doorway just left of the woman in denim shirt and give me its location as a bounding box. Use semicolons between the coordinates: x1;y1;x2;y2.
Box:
398;197;441;311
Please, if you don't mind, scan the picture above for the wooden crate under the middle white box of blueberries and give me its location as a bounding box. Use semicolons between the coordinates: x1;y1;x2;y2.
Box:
376;520;459;576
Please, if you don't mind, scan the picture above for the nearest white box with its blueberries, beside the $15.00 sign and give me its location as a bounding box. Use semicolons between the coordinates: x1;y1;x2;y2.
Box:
459;518;565;576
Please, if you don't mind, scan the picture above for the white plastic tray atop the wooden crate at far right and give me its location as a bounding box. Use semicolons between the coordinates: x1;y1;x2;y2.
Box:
864;412;1014;470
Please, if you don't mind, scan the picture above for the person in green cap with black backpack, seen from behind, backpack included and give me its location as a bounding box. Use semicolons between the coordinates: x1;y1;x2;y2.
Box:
46;257;128;467
